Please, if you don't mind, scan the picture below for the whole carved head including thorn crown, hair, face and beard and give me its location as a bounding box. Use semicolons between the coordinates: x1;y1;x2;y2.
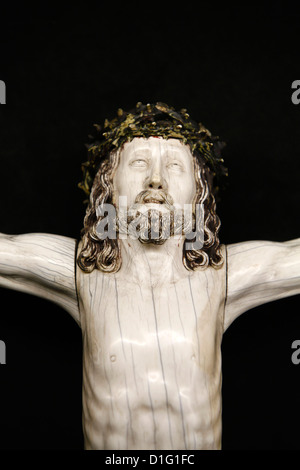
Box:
77;103;226;272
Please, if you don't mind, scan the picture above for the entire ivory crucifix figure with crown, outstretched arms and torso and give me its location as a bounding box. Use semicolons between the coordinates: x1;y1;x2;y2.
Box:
0;103;300;450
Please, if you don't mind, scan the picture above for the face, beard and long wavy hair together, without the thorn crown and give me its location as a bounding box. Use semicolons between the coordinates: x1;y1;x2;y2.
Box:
78;133;223;272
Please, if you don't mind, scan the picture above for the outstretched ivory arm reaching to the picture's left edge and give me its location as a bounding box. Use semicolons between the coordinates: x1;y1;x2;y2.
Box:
0;233;80;325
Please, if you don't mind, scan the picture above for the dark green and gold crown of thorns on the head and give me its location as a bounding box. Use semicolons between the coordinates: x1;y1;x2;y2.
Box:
78;102;227;196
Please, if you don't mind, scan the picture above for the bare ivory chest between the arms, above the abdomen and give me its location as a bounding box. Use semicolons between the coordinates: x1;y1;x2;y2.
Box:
79;276;222;371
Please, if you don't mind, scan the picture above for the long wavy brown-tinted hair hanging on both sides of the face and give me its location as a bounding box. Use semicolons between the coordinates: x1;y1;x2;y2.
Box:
77;145;224;273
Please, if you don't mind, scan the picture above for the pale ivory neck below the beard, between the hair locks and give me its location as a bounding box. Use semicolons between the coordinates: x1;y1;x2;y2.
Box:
120;236;188;287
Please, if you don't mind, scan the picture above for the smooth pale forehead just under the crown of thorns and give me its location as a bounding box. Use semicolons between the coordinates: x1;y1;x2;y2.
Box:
121;137;192;160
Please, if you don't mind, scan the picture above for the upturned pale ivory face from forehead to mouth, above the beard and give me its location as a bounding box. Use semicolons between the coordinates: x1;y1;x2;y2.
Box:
113;137;196;209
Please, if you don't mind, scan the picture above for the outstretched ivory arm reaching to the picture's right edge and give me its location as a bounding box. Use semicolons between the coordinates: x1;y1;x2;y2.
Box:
224;238;300;330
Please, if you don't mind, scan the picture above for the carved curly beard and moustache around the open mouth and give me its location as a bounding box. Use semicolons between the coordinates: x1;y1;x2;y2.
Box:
117;190;192;245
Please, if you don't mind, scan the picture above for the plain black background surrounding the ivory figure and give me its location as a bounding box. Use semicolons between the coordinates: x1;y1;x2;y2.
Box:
0;1;300;450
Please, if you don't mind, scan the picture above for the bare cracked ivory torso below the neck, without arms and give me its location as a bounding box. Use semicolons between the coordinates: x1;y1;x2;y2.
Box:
77;244;226;450
